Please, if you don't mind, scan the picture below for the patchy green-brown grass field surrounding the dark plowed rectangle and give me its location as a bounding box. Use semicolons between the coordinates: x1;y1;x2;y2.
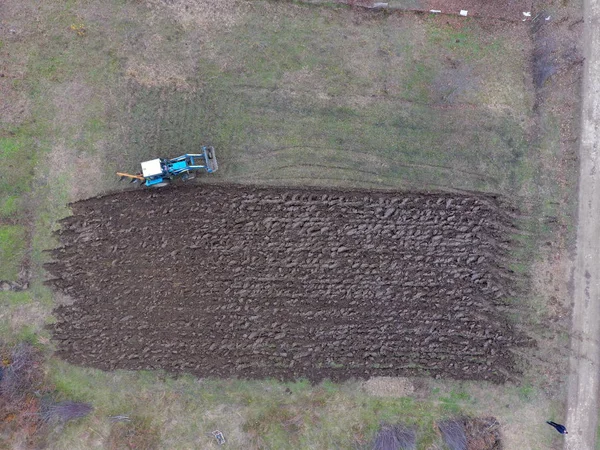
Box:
0;0;573;449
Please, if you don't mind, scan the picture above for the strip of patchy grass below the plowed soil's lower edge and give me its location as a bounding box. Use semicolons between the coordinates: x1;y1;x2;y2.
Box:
49;360;560;450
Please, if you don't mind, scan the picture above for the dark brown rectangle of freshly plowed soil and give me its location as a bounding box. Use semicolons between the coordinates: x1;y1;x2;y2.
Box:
48;185;526;382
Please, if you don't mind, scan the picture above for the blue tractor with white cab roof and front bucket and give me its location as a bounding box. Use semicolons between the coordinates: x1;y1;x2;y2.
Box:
117;146;219;187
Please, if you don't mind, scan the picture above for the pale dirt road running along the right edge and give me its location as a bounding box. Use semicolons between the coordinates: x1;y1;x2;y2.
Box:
565;0;600;450
